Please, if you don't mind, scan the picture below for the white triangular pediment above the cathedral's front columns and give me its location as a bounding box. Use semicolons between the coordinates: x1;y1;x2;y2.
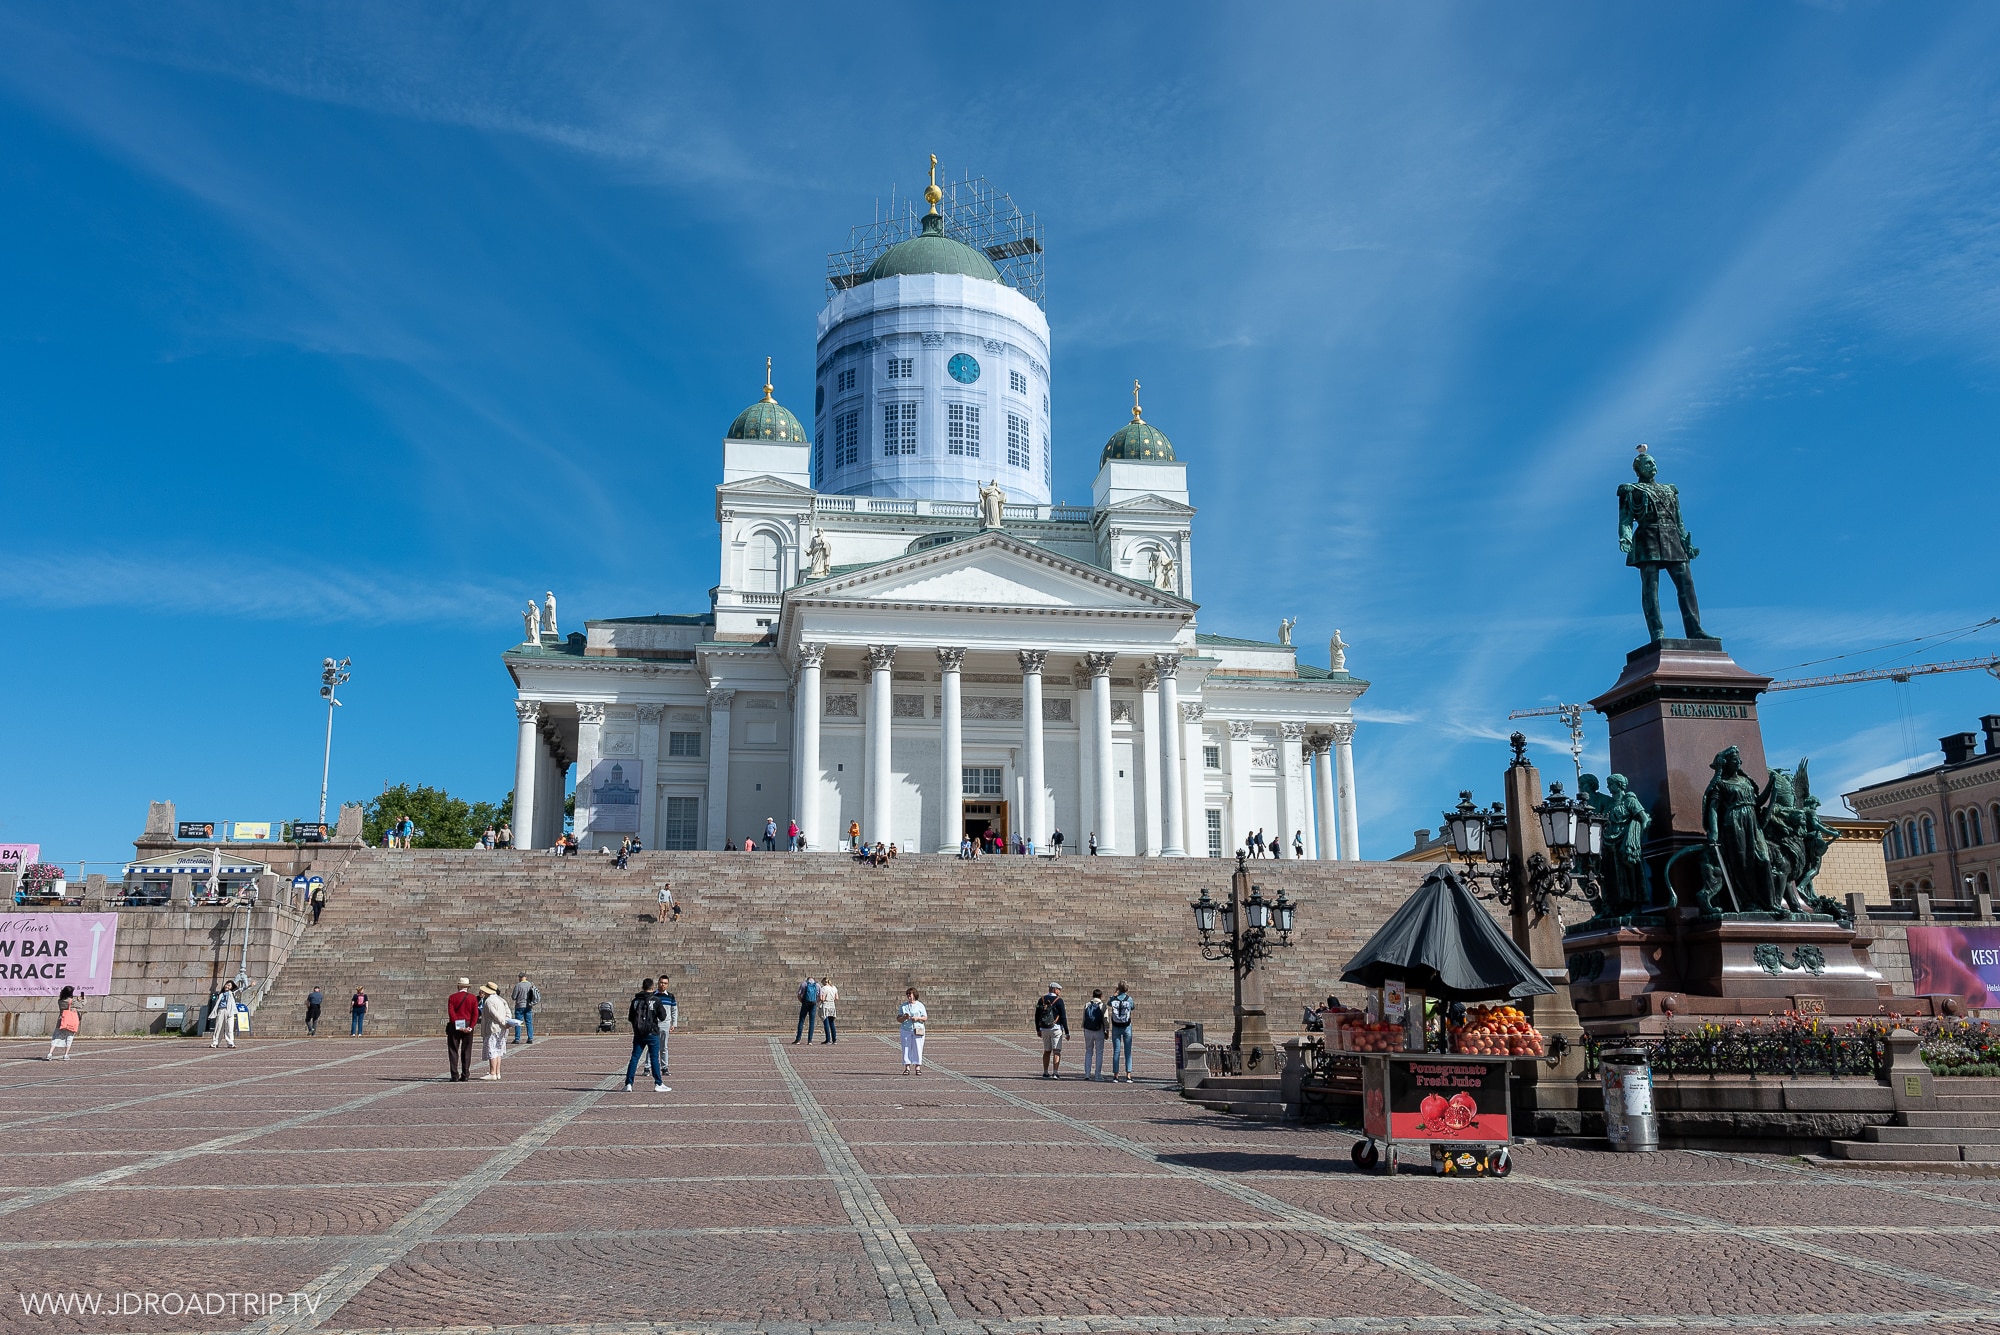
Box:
788;534;1194;616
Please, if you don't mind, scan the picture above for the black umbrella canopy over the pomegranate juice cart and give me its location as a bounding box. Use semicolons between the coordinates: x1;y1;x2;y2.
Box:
1340;867;1556;1001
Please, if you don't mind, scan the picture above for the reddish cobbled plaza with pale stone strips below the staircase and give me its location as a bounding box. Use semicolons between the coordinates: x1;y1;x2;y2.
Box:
0;1033;2000;1335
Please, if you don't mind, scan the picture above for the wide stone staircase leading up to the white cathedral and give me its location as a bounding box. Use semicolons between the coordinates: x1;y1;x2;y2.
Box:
258;849;1426;1041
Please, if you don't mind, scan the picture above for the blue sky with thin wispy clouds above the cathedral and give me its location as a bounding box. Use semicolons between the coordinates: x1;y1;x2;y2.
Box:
0;4;2000;863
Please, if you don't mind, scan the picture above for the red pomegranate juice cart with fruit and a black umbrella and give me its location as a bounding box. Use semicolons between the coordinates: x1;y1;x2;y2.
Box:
1340;867;1554;1177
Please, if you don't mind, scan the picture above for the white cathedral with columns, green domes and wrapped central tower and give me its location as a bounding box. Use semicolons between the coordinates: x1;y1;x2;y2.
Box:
504;174;1368;857
